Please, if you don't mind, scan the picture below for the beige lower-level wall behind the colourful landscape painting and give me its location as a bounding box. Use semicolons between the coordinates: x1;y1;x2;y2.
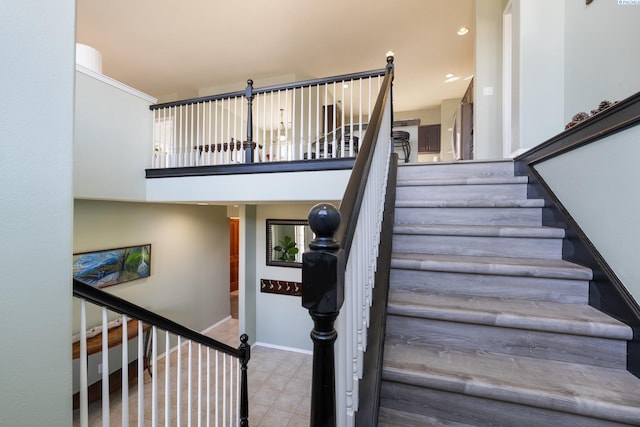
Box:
73;200;229;332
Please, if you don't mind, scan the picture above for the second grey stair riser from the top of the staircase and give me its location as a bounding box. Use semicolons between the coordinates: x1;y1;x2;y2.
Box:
396;184;527;200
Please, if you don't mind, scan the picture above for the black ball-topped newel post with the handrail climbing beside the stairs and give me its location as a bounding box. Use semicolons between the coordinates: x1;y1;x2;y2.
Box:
302;56;393;427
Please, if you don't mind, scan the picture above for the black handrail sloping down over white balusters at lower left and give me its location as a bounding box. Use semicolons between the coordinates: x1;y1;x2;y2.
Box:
73;279;244;359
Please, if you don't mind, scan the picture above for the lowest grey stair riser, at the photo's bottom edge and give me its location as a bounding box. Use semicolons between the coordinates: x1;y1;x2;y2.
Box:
380;382;622;427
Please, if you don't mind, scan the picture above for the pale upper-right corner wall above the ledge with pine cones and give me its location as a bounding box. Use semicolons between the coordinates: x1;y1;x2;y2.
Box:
563;0;640;123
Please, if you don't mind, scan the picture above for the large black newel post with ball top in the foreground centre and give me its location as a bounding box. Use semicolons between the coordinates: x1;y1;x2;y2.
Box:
302;203;344;427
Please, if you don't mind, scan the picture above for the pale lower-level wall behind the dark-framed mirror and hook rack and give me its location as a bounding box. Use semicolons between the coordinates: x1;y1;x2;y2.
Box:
247;203;315;351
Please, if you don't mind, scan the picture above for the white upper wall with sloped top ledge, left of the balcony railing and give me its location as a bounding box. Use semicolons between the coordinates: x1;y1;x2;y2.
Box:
73;71;154;201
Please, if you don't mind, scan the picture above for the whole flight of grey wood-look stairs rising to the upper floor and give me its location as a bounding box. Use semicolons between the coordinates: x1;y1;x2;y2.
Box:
379;161;640;427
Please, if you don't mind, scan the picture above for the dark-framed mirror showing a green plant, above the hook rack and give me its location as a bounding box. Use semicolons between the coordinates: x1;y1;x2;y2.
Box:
266;219;313;268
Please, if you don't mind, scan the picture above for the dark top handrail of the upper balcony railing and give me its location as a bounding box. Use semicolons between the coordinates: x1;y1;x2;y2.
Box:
149;68;386;110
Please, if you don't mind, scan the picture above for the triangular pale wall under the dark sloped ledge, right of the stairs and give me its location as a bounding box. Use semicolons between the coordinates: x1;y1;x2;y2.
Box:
536;126;640;302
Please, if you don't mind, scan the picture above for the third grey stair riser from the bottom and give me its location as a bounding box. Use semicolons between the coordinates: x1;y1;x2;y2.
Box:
390;268;589;304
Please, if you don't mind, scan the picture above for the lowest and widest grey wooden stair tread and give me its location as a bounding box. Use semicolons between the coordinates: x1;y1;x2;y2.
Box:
383;344;640;425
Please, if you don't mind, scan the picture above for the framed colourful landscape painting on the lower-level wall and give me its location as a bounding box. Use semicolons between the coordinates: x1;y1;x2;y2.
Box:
73;244;151;288
